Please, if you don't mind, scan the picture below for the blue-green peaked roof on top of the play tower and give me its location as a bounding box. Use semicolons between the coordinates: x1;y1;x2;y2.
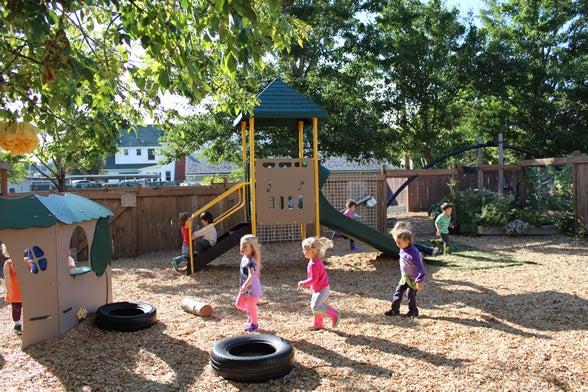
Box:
233;78;327;127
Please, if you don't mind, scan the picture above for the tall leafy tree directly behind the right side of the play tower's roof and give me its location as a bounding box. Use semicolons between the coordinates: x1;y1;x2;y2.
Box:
274;0;395;162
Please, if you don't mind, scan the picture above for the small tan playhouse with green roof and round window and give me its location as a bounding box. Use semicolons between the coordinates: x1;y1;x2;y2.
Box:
0;193;112;348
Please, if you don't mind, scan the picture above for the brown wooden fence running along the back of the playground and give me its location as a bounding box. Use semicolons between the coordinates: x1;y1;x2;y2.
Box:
0;157;588;259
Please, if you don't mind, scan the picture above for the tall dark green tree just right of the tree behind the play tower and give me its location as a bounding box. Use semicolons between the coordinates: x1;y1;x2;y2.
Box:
361;0;471;163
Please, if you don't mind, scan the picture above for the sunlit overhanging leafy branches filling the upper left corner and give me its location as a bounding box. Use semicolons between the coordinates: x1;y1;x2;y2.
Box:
0;0;306;190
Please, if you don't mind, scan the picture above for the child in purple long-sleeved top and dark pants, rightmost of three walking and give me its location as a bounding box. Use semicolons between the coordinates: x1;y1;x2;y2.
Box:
384;225;425;317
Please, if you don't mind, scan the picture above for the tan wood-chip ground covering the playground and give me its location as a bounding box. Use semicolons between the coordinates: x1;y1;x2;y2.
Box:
0;236;588;391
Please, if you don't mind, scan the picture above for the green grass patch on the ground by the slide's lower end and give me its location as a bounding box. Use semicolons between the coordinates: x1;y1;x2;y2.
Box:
423;242;536;270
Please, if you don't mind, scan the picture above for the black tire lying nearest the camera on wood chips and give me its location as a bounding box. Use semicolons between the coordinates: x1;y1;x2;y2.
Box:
210;334;294;383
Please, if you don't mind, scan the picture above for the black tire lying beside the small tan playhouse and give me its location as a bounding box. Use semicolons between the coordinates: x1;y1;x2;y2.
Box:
96;301;157;332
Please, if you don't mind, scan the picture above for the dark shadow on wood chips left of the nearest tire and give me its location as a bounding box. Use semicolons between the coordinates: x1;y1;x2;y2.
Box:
26;317;209;391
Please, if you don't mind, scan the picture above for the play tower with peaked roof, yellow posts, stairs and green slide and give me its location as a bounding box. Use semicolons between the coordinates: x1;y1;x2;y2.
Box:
186;78;398;274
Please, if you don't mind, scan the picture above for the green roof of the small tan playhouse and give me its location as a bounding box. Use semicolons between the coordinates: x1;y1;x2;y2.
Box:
0;193;114;230
